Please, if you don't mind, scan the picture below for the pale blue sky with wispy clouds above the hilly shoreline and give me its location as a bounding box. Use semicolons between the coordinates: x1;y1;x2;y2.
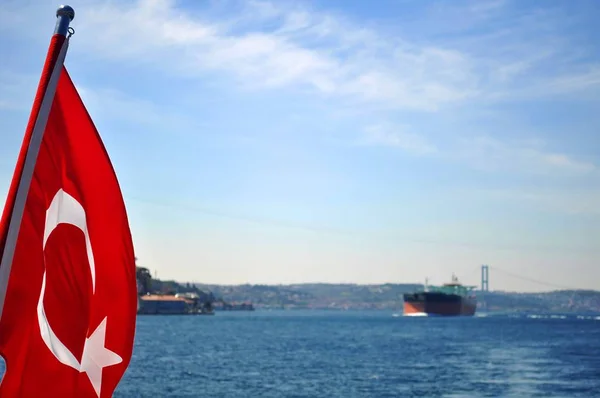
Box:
0;0;600;290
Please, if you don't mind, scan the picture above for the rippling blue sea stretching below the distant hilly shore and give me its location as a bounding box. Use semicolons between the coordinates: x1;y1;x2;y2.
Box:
115;311;600;398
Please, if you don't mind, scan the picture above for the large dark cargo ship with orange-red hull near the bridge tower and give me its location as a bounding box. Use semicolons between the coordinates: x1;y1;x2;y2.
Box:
403;274;477;316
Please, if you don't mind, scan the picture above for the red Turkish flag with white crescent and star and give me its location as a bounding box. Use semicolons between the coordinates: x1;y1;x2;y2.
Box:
0;37;137;397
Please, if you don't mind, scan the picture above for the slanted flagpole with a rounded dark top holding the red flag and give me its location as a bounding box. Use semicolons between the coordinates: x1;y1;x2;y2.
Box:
0;5;75;319
